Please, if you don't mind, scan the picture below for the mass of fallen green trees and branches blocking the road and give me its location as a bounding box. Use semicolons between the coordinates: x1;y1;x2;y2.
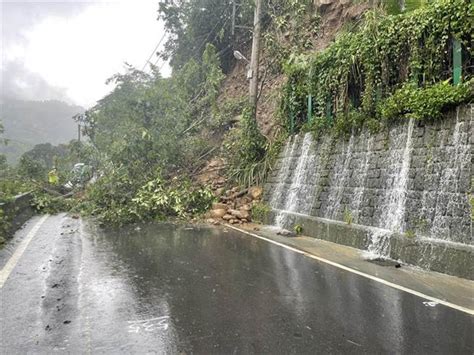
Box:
58;44;224;225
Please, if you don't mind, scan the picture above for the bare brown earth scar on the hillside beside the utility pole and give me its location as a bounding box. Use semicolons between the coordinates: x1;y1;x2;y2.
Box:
219;0;371;138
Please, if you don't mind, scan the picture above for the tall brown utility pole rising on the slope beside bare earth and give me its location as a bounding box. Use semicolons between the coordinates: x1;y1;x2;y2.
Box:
249;0;262;117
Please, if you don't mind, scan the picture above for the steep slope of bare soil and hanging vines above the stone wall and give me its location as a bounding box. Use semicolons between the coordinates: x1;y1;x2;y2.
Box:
202;0;473;225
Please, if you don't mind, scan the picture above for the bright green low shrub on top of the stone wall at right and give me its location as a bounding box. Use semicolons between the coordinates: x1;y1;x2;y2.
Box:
378;79;474;120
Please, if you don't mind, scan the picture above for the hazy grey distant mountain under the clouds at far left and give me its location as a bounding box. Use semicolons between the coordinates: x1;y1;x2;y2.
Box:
0;99;84;164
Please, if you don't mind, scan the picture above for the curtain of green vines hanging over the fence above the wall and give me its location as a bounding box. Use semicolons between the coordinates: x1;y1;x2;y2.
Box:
281;0;474;135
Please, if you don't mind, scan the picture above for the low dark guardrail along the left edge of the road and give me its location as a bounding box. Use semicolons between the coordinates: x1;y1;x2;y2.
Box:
0;192;35;239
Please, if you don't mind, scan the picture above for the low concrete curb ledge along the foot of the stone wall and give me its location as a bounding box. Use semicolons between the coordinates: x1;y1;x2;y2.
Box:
266;209;474;280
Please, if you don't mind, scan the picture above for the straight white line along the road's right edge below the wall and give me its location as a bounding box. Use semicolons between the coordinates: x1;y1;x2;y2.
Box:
225;224;474;315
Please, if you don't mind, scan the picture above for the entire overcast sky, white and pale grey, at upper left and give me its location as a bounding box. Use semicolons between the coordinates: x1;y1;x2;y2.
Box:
0;0;169;108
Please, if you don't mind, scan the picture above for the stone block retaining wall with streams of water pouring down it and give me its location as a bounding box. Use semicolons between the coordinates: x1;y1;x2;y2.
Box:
265;106;474;244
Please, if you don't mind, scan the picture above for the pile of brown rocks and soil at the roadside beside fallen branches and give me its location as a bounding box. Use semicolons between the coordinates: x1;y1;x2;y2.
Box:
207;186;263;224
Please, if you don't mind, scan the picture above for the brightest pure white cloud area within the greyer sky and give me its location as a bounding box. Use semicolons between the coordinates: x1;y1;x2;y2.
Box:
5;0;169;107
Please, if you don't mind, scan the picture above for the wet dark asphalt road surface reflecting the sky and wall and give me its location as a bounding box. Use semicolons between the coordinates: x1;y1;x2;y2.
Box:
0;216;474;354
